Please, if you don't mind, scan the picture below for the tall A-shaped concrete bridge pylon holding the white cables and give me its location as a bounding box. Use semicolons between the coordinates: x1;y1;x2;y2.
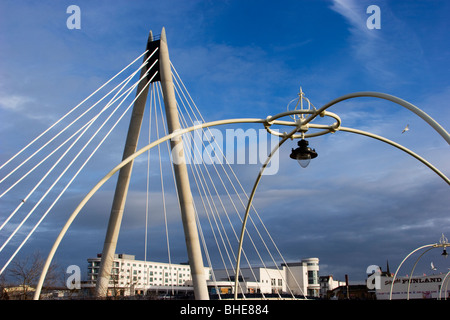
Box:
96;28;209;300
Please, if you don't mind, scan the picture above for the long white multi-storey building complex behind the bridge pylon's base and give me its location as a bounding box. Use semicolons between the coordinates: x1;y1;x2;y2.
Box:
83;254;320;297
